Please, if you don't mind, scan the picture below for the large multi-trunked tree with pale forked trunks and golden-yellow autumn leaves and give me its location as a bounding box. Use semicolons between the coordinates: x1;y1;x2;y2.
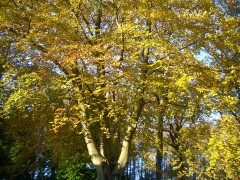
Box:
0;0;239;180
